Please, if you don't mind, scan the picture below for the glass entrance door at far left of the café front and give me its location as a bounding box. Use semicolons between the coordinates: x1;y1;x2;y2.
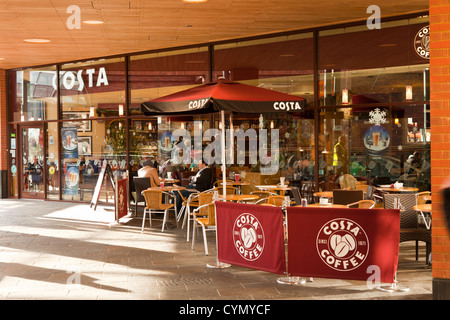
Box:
21;127;44;199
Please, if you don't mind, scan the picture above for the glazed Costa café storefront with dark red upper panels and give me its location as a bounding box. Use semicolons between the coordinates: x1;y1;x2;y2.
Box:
4;12;430;202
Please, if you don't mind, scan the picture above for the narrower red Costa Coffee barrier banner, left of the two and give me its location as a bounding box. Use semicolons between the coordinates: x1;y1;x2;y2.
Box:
216;201;286;274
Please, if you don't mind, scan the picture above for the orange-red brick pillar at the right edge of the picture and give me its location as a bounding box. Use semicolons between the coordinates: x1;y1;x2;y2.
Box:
429;0;450;299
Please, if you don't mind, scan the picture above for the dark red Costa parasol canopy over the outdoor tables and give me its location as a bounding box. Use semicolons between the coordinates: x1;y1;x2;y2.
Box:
141;80;305;116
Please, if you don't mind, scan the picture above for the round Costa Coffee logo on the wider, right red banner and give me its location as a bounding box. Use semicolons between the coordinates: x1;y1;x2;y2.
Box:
316;218;369;271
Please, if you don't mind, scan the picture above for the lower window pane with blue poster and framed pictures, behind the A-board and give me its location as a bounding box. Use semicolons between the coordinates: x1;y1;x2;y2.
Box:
61;120;127;202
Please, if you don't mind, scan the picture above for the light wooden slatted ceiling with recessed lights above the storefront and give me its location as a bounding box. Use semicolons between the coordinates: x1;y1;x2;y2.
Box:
0;0;428;69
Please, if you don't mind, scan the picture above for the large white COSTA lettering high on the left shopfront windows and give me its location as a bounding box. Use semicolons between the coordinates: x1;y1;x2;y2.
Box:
52;67;109;91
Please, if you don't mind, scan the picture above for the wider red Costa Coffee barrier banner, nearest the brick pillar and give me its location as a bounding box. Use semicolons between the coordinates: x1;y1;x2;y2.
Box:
287;207;400;283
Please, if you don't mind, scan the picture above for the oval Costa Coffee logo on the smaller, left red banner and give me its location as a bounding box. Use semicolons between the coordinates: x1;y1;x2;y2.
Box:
233;213;265;261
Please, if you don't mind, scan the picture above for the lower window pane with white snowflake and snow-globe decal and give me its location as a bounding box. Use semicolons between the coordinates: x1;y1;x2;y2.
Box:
319;105;431;190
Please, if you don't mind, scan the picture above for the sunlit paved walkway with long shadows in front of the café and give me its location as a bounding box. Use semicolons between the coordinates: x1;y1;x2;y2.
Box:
0;199;432;300
